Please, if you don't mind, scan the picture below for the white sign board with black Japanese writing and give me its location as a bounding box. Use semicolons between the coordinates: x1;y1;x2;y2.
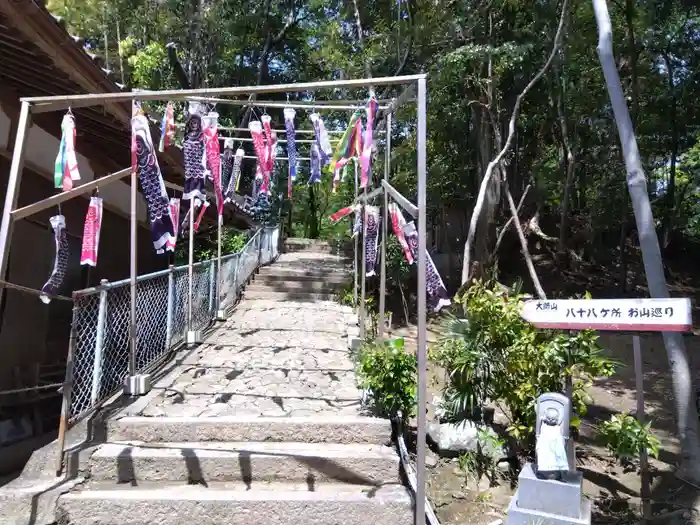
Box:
521;299;693;332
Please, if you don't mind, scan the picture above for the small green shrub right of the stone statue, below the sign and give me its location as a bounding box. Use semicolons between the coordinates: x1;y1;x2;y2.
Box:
598;414;661;463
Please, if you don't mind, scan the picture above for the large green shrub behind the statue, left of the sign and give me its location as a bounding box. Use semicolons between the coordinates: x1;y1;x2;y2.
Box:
431;281;615;445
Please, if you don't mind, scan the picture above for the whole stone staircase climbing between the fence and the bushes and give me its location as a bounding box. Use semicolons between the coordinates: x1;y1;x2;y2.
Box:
56;240;413;525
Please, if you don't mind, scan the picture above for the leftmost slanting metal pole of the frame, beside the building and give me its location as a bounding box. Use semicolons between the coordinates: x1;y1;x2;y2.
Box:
0;102;31;297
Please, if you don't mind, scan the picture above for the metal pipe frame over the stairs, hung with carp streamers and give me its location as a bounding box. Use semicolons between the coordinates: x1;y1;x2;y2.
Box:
0;73;427;525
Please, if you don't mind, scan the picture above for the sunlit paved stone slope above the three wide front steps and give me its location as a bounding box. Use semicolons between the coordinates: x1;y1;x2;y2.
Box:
141;294;361;417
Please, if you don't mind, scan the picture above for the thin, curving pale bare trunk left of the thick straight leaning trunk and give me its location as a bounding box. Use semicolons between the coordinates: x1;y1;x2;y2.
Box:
462;0;568;285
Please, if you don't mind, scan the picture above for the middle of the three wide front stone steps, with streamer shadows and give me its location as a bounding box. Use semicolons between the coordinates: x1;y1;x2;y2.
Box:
90;442;400;485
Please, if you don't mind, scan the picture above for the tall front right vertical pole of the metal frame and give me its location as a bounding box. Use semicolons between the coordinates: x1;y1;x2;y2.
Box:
416;77;428;525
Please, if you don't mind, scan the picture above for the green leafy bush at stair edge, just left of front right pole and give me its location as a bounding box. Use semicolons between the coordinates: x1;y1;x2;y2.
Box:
357;338;417;418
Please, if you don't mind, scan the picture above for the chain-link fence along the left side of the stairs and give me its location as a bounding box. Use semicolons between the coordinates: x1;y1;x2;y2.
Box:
67;227;279;423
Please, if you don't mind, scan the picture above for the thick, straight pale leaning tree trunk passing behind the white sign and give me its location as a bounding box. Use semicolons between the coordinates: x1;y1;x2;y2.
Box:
593;0;700;483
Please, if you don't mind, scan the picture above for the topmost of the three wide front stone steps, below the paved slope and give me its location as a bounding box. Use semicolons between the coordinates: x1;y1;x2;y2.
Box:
108;415;391;445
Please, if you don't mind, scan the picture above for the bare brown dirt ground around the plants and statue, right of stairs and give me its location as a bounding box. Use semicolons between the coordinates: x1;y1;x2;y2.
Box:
393;326;700;525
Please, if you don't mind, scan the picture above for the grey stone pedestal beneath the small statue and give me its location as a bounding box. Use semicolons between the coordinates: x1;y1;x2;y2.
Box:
506;463;591;525
